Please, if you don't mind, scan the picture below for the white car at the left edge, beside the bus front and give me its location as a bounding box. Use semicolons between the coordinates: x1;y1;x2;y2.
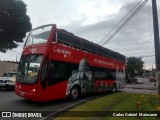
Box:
0;71;17;89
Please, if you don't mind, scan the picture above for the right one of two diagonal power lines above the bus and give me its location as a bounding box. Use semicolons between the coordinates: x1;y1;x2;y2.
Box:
102;0;148;46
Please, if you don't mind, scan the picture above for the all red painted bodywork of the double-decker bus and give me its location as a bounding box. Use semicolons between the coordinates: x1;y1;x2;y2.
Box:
15;25;125;101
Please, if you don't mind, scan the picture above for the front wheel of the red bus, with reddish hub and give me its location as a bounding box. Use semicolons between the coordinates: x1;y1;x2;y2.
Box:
69;87;80;100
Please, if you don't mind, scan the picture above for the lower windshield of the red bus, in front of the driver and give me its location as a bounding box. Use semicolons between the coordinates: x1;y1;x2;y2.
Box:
17;55;42;84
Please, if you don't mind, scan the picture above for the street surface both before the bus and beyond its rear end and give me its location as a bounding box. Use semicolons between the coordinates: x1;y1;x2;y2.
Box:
0;79;157;119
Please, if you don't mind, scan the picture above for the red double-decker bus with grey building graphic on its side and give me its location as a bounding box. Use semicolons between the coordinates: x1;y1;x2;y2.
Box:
15;24;125;101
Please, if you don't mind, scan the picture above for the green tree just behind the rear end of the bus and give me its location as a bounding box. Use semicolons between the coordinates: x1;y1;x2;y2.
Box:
126;57;144;77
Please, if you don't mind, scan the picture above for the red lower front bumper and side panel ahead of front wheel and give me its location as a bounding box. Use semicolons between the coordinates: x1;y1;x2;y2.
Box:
15;81;67;101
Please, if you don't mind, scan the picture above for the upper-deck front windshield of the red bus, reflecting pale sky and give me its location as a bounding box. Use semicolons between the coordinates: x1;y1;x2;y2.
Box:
25;25;52;46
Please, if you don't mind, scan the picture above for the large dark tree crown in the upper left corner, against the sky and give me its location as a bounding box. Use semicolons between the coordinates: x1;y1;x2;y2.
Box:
0;0;32;53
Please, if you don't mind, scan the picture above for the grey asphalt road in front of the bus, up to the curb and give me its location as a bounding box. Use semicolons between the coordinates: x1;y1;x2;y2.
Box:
0;89;95;119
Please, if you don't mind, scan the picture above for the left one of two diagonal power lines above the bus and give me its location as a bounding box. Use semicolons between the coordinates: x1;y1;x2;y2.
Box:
99;1;141;44
